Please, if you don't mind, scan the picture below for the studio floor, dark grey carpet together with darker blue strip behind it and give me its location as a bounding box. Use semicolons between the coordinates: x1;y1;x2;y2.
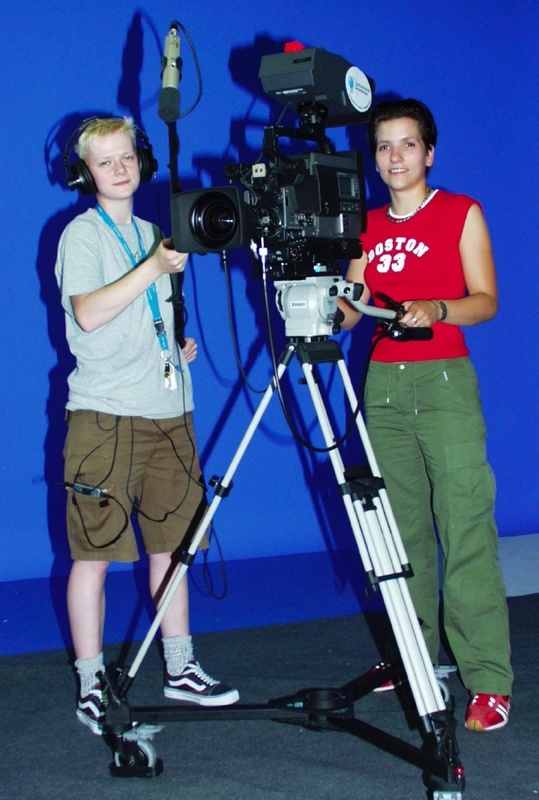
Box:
0;535;539;800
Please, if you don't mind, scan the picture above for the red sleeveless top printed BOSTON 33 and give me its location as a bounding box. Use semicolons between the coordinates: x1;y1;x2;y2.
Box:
361;189;476;362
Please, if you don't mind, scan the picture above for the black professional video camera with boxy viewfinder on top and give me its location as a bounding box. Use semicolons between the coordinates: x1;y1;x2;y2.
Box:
171;46;374;280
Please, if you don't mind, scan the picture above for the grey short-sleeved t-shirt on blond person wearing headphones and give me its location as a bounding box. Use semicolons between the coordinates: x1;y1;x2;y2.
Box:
55;209;193;419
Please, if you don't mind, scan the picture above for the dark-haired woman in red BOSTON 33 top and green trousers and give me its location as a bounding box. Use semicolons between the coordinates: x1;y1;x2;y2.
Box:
339;100;513;731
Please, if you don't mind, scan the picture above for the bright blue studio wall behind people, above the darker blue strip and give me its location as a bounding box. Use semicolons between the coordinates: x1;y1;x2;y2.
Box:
0;0;539;644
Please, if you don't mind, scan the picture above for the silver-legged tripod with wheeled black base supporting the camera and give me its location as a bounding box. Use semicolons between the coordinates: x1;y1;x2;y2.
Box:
105;278;464;800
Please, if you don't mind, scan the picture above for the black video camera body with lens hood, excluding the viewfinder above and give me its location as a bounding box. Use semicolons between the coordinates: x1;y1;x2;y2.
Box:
171;129;365;280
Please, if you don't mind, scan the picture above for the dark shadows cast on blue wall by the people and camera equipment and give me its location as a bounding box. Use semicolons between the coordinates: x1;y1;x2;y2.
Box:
37;18;396;646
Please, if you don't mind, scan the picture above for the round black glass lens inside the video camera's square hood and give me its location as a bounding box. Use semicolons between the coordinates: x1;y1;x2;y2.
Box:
191;191;238;250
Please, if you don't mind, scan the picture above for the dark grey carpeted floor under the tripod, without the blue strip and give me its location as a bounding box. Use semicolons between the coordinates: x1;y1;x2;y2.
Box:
0;535;539;800
